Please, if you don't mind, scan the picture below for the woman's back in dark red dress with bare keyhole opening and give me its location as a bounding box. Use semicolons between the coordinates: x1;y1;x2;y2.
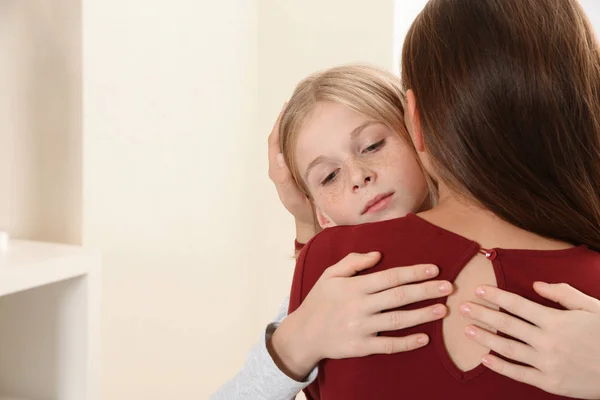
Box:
290;211;600;400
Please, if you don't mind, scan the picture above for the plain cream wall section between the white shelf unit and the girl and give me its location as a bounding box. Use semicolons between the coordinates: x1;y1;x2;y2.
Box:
83;0;262;400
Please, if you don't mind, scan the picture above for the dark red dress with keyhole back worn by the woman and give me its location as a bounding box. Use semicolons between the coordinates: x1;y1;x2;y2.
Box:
289;214;600;400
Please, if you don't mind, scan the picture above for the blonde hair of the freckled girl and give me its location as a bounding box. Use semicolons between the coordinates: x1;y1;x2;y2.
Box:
279;65;436;199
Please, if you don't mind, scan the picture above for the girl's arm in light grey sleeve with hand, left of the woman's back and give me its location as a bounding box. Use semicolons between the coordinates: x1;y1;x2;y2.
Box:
211;253;452;400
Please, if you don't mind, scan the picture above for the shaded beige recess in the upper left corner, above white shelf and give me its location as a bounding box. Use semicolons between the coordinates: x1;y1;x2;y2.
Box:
0;0;81;243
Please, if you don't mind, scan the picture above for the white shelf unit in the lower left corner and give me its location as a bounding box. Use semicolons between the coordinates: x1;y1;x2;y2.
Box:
0;240;101;400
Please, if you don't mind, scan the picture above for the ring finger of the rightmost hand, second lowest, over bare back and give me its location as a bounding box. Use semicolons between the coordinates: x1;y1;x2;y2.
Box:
465;325;538;365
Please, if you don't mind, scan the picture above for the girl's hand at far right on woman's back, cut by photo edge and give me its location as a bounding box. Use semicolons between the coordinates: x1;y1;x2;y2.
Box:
461;282;600;399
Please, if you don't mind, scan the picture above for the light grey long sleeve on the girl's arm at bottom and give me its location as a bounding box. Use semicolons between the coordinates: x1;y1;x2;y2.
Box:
210;297;318;400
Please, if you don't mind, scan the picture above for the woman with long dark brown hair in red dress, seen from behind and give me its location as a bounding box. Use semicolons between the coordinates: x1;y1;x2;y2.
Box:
290;0;600;398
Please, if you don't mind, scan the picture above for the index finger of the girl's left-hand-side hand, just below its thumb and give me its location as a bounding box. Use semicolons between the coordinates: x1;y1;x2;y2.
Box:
359;264;440;293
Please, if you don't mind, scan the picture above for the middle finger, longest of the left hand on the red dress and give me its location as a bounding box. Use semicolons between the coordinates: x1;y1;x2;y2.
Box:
365;281;452;313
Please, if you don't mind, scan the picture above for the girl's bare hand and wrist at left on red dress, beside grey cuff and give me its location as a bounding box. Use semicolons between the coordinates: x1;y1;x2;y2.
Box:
270;253;452;380
